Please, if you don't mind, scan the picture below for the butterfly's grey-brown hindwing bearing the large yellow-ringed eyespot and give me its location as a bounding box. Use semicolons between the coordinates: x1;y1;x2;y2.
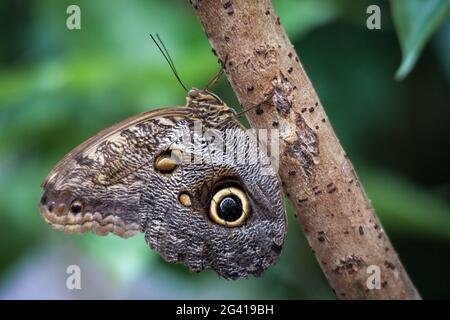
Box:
141;121;287;279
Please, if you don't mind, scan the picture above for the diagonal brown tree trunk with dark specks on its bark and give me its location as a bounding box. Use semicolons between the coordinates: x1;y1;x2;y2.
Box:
192;0;420;299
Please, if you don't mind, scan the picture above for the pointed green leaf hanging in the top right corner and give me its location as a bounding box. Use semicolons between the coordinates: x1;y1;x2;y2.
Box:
391;0;450;80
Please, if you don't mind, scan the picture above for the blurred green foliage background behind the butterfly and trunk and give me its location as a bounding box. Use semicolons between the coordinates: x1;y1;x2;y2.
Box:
0;0;450;299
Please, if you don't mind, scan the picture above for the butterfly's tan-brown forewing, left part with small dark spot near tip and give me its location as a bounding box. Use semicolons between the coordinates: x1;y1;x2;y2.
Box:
40;107;189;237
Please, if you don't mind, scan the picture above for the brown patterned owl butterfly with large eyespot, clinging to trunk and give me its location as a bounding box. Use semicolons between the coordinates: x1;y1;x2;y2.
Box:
40;89;286;279
